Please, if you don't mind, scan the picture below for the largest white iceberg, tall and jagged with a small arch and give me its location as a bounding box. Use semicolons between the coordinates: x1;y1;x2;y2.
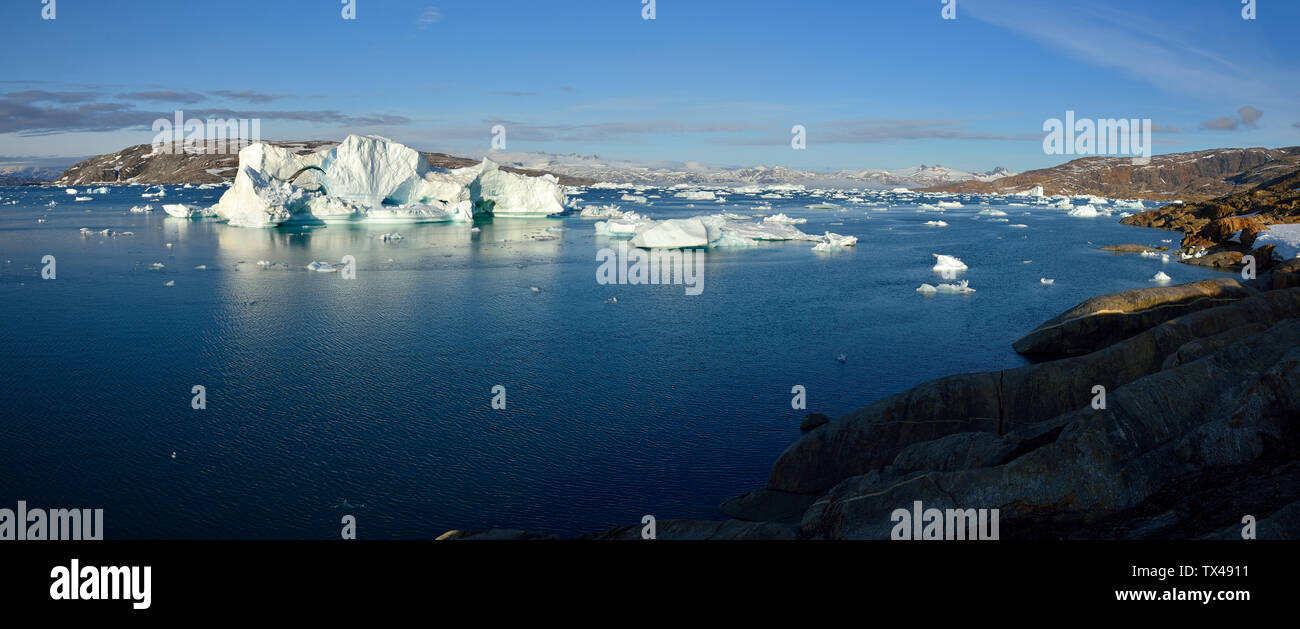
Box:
213;135;564;227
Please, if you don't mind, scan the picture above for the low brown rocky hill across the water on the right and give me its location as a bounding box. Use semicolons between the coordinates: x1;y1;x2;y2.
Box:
930;147;1300;201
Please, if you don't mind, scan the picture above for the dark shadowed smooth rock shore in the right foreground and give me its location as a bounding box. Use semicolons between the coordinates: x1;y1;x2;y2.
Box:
441;260;1300;539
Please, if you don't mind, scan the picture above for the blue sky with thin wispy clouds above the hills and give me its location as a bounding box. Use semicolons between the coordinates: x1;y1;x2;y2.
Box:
0;0;1300;170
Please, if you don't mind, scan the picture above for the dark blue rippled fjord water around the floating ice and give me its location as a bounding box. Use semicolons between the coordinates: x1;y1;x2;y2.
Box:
0;187;1214;538
